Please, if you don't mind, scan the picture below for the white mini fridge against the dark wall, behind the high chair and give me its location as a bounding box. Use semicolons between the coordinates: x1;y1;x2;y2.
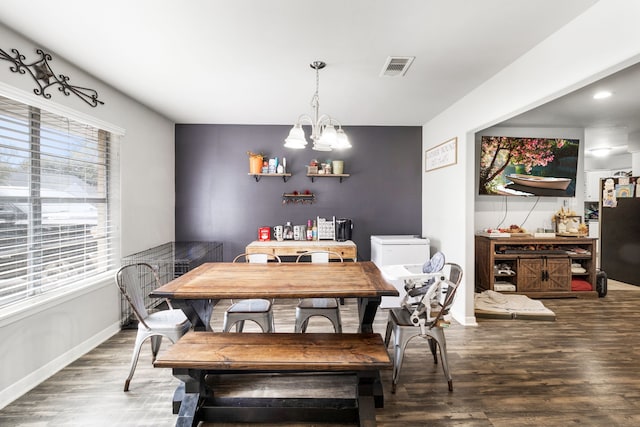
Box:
371;235;431;308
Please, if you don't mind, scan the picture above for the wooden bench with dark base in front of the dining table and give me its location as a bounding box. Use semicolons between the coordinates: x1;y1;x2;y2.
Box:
154;331;392;427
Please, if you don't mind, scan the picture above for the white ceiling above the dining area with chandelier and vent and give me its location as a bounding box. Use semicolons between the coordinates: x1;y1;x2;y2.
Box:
0;0;597;125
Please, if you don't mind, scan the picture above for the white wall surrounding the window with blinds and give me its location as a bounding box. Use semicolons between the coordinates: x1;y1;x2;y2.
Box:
0;25;175;408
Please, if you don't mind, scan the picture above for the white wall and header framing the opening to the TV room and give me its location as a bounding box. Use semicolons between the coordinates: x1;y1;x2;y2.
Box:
423;0;640;325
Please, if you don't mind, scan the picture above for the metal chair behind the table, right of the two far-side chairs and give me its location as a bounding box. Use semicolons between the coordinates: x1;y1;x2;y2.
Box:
295;251;344;333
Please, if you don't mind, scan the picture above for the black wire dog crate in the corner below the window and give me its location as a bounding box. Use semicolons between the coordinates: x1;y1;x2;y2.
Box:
120;242;222;328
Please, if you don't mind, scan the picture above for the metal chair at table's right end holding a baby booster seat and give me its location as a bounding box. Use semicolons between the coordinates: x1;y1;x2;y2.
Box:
384;263;462;393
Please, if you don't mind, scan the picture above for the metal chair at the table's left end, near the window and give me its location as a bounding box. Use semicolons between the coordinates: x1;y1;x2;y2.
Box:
116;263;191;391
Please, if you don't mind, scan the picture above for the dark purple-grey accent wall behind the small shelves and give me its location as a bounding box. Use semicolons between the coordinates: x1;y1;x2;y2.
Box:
176;124;422;261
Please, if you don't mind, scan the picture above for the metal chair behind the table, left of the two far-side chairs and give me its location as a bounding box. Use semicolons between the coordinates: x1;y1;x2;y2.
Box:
222;253;281;332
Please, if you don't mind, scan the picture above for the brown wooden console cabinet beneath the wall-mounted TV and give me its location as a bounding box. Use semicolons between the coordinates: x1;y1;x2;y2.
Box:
475;235;598;298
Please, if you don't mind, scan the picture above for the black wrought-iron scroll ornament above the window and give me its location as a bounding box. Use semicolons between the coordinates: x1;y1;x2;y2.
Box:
0;49;104;107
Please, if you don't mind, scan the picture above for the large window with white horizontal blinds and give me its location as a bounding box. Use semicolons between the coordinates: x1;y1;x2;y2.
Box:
0;97;115;308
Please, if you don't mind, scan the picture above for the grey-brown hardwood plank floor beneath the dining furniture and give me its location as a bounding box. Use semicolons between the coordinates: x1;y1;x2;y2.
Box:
0;281;640;427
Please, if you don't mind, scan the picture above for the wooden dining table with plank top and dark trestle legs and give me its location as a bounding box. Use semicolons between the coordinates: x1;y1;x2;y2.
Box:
150;261;398;333
